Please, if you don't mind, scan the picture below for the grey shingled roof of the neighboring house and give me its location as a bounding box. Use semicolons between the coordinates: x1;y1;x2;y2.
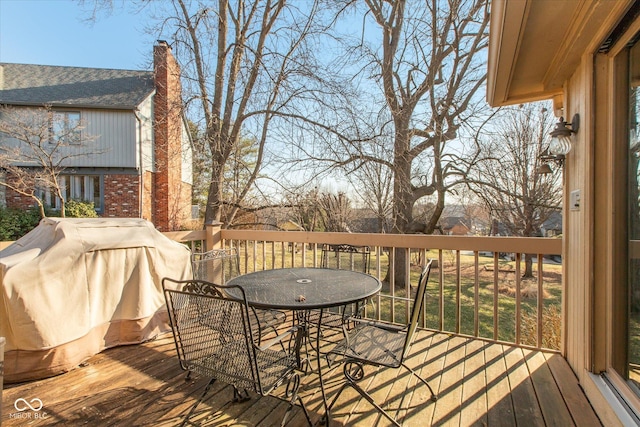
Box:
0;63;155;109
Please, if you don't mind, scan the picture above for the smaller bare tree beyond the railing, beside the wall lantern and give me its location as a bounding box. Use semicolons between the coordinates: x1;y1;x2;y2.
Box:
470;103;562;277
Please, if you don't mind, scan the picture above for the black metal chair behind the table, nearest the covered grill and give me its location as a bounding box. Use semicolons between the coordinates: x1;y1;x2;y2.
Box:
191;248;287;340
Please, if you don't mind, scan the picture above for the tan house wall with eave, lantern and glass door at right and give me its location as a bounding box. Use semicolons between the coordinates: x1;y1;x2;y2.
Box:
487;0;640;426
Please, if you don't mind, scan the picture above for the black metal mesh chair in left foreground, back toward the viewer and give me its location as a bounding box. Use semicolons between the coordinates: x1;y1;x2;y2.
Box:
162;278;311;426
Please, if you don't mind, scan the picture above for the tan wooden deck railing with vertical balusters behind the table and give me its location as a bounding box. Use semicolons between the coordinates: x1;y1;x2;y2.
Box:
165;228;562;351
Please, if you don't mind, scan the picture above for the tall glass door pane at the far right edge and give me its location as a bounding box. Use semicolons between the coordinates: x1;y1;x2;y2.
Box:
607;33;640;402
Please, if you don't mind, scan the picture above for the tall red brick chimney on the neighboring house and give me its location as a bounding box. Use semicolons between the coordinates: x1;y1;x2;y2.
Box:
153;40;191;231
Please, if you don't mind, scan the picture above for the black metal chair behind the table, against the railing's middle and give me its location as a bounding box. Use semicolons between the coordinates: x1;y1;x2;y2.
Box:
310;244;371;329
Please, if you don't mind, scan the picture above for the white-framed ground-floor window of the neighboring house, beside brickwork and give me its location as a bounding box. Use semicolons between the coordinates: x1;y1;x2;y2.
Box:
37;175;102;212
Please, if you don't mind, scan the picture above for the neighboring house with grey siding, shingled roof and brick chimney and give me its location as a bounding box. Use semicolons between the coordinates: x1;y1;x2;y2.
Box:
0;41;192;231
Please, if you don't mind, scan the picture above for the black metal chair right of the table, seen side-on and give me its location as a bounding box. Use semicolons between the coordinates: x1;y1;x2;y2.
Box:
327;261;437;426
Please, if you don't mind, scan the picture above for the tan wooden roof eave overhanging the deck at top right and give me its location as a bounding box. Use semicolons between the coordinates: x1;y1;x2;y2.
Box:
487;0;634;109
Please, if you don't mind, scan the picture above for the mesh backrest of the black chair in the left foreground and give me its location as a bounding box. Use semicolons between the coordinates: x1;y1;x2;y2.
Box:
162;278;261;392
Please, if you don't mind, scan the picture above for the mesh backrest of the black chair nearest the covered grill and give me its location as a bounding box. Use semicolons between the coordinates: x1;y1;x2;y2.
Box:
191;248;240;283
